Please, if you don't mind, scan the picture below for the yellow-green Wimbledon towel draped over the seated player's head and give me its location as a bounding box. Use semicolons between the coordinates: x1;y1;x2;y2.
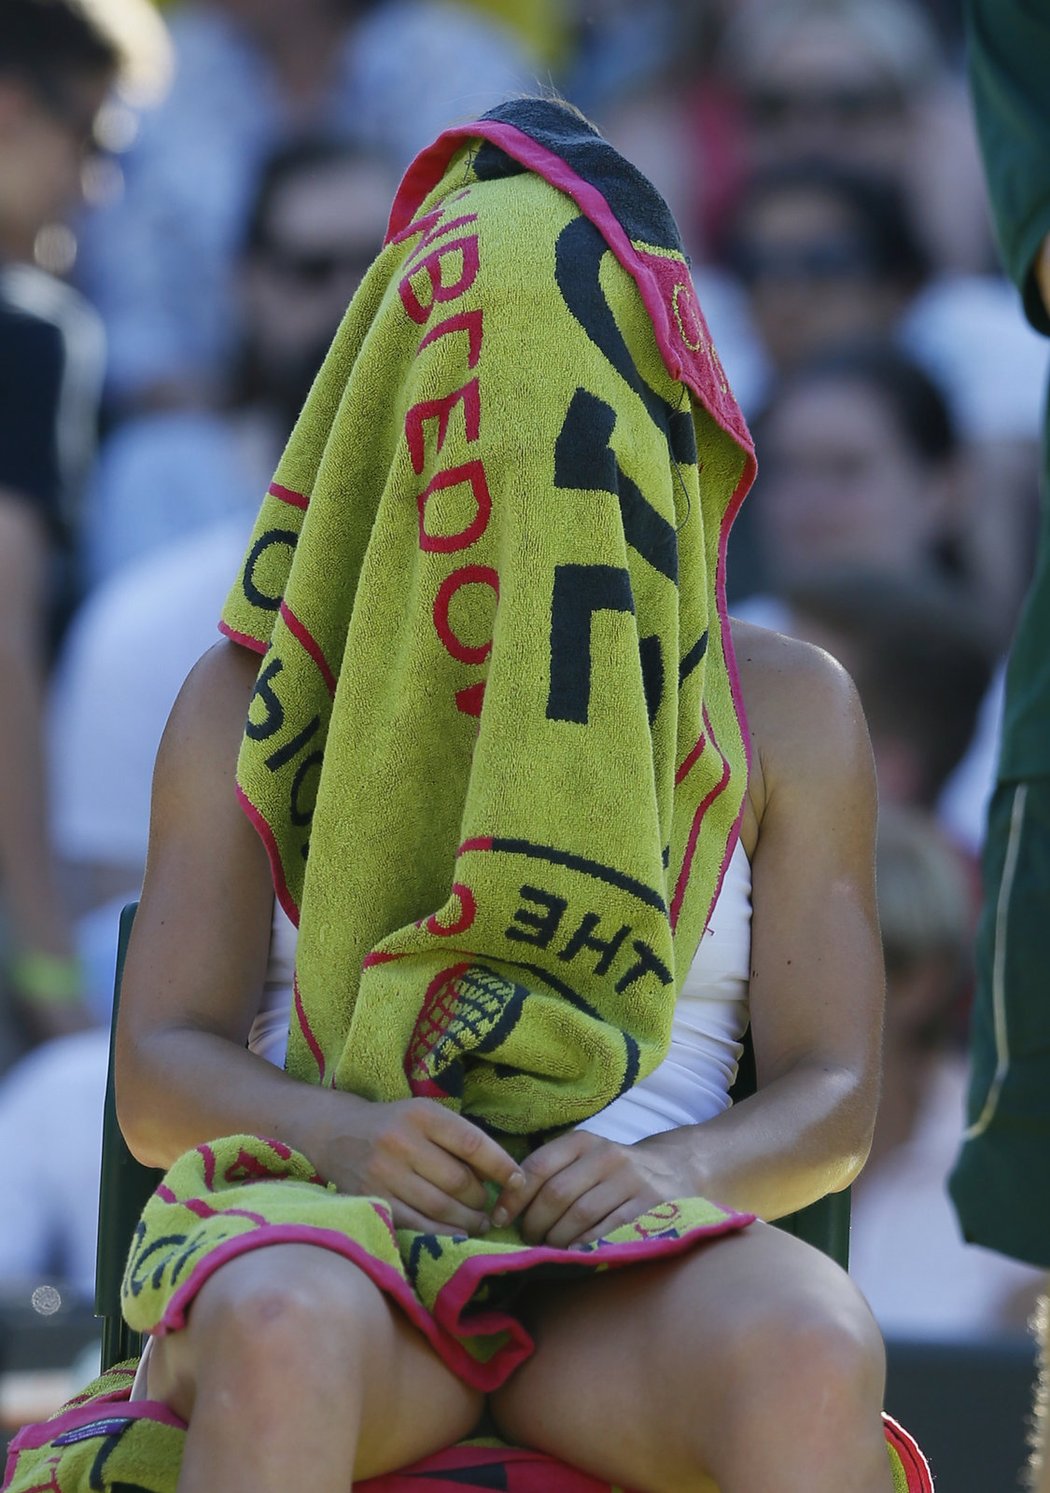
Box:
223;100;753;1122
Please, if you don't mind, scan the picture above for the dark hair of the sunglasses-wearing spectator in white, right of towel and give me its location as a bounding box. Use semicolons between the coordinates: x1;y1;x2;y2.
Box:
726;160;931;291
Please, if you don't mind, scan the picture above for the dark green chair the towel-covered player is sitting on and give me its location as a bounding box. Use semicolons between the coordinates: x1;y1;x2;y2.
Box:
94;902;850;1371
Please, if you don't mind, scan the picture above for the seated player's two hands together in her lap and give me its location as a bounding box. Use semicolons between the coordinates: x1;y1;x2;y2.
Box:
327;1099;690;1248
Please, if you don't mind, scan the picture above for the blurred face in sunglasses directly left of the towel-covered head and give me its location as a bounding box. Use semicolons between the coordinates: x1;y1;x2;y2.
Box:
240;158;394;406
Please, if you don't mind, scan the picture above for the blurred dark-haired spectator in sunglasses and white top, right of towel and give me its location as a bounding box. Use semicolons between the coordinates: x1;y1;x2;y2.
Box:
696;160;1047;513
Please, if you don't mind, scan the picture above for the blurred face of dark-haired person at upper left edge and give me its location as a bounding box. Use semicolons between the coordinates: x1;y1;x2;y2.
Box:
0;75;109;257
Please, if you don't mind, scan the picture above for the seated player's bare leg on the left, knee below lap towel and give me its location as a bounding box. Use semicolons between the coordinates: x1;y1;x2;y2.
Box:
148;1244;482;1493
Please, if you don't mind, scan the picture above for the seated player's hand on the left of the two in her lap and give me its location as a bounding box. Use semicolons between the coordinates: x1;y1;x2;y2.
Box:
311;1094;526;1235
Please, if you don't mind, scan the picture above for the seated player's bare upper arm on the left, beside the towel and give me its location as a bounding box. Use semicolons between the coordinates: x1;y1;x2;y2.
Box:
117;642;273;1081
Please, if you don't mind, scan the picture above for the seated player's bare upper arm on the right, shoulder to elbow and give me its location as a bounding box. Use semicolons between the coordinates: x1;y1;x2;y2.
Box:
742;638;884;1102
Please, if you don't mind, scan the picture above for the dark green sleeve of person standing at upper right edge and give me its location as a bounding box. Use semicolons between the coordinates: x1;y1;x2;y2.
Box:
966;0;1050;333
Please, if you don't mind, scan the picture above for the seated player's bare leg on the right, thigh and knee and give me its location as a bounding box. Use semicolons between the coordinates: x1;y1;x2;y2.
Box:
491;1224;892;1493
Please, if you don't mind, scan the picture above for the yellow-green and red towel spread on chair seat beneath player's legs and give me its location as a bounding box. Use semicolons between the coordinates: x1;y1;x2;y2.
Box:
3;1362;933;1493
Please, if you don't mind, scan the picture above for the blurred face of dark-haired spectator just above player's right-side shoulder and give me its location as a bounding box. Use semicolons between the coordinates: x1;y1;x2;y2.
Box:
756;379;950;584
